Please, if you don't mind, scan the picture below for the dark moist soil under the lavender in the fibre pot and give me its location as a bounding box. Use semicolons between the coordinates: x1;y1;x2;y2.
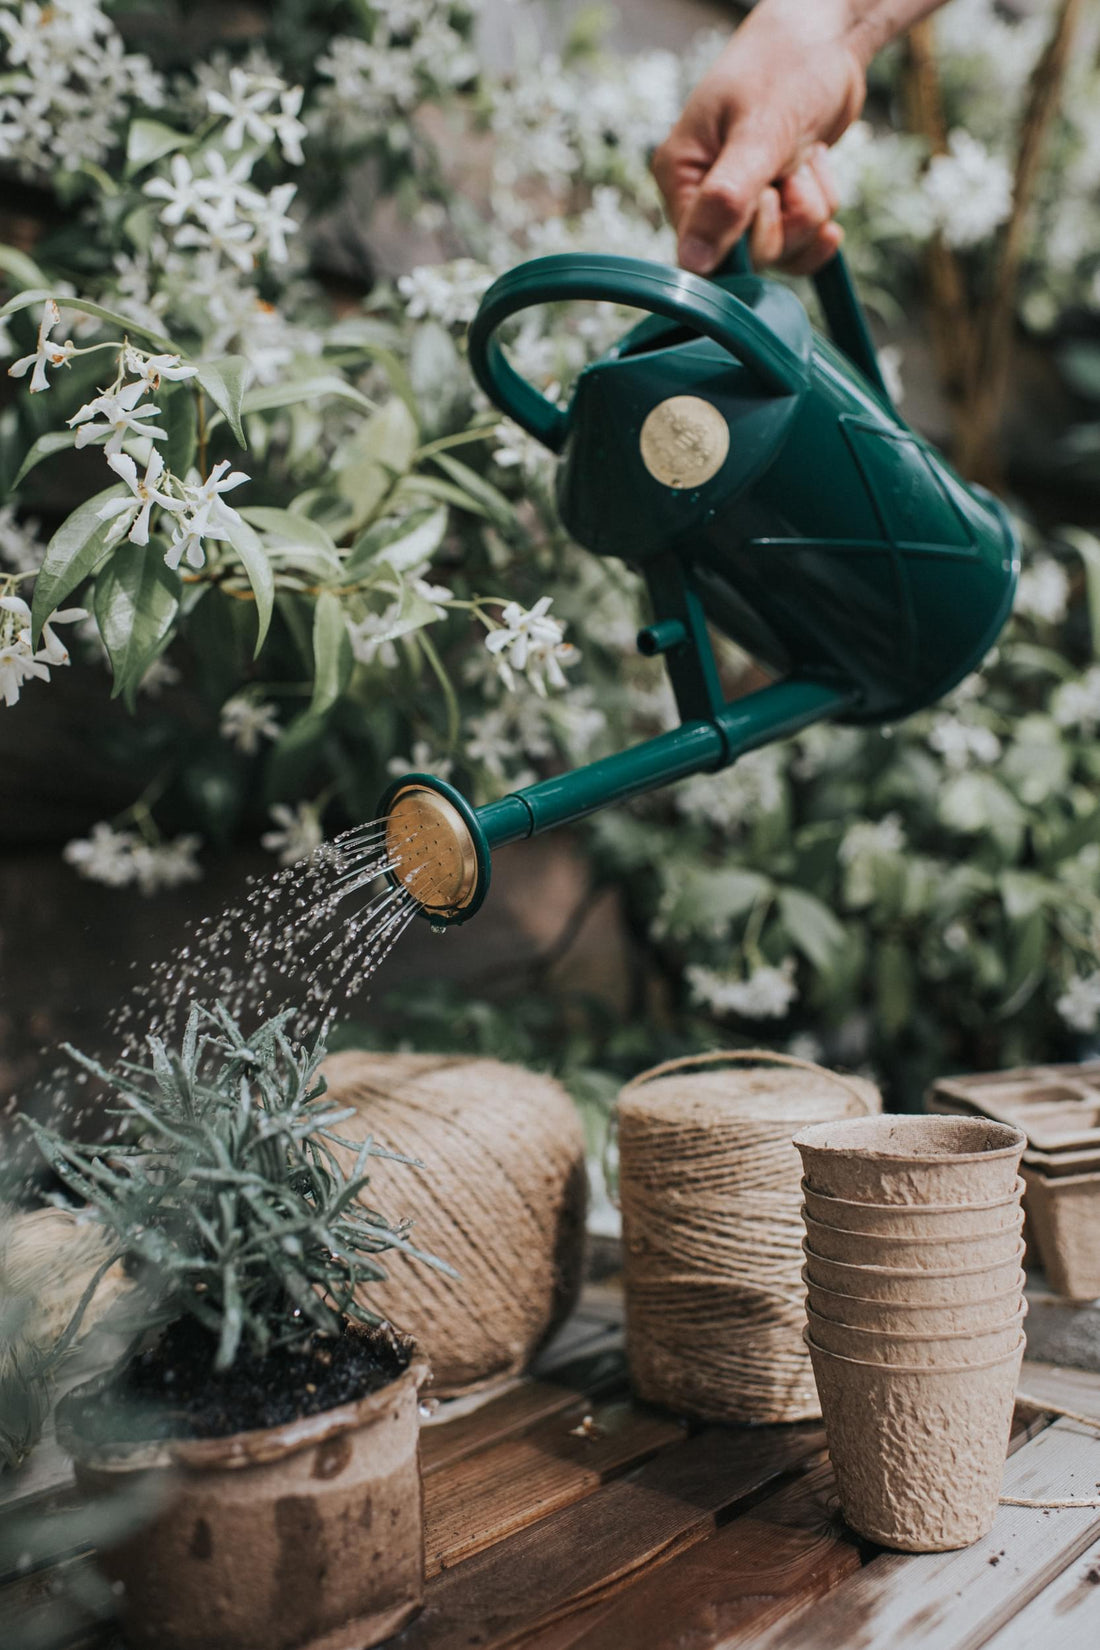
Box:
68;1318;414;1444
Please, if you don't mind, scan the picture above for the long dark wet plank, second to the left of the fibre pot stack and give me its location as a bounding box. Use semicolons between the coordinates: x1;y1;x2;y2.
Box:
394;1426;825;1650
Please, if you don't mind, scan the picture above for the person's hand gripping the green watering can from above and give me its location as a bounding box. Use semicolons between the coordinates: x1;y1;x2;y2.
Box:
653;0;870;274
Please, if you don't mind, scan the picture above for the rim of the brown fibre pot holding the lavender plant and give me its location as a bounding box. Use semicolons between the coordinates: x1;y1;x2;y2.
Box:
54;1353;430;1472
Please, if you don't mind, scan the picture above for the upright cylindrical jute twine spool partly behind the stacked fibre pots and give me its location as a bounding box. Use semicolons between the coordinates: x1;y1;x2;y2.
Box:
617;1049;882;1422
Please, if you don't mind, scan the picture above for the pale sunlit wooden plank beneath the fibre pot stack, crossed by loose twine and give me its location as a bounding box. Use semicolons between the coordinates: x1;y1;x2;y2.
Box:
754;1421;1100;1650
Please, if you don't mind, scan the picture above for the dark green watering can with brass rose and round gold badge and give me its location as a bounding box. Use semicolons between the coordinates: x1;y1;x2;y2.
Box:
381;240;1019;926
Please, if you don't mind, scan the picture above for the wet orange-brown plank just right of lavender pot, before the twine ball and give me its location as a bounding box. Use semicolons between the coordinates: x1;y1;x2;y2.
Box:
424;1398;684;1576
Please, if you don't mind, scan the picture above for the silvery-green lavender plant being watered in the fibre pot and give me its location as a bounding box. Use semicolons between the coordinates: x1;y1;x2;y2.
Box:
31;1005;449;1370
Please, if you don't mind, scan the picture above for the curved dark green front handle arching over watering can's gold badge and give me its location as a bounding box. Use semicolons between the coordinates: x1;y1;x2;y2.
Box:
470;252;808;452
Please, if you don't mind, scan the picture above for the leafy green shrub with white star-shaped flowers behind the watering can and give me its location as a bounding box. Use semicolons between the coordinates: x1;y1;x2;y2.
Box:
0;0;1100;1087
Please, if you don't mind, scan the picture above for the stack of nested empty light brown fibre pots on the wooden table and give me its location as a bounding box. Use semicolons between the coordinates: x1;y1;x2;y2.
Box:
795;1117;1026;1553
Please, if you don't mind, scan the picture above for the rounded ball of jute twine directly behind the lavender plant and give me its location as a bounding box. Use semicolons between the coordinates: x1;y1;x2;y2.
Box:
323;1051;587;1398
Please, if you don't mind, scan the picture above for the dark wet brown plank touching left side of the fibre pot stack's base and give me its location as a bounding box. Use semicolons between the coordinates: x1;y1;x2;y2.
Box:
524;1462;863;1650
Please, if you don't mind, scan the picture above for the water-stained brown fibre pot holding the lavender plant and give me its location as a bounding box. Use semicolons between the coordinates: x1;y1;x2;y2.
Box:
58;1360;427;1650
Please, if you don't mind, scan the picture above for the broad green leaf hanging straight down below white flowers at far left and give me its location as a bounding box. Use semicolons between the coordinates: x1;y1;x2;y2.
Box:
96;540;180;710
